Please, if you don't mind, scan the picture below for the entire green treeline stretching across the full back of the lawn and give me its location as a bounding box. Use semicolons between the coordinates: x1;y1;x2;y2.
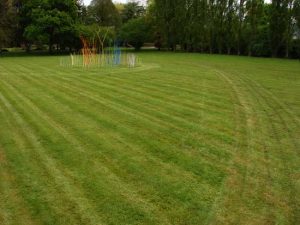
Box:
0;0;300;58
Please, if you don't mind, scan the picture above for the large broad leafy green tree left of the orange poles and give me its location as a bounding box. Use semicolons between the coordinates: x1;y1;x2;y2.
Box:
24;0;79;53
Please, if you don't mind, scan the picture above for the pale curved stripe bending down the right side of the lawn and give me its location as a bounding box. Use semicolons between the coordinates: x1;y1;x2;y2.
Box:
205;70;255;224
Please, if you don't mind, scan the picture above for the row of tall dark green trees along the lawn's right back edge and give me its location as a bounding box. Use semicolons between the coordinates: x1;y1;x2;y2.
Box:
152;0;300;57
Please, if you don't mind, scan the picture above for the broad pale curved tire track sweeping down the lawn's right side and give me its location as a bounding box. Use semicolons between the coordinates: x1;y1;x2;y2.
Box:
201;65;254;224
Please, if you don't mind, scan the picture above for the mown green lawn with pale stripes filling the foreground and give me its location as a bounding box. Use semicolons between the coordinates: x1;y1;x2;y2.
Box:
0;52;300;225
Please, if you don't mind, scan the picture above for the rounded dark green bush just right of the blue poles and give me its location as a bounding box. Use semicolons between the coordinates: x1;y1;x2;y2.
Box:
120;17;149;50
